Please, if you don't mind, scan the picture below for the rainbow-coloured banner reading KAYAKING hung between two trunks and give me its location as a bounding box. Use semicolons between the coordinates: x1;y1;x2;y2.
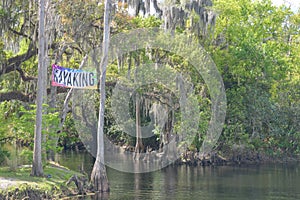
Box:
52;64;98;89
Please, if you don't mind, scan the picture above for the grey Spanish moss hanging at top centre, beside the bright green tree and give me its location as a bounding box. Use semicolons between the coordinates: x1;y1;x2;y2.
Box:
128;0;216;39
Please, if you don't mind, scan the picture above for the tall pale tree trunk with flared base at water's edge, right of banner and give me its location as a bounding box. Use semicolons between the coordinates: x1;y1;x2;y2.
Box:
91;0;111;192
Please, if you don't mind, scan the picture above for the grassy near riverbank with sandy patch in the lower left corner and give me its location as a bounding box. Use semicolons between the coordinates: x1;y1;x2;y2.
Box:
0;164;86;200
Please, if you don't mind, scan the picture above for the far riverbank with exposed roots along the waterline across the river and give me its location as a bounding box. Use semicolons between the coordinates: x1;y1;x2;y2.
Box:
122;143;300;166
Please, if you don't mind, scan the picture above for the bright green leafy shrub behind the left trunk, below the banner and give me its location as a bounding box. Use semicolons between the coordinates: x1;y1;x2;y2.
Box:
0;101;59;150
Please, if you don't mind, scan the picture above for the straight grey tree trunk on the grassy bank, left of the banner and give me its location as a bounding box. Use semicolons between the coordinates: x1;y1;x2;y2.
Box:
31;0;47;176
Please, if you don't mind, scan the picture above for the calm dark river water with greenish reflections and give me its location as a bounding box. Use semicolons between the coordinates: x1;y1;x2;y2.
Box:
58;153;300;200
